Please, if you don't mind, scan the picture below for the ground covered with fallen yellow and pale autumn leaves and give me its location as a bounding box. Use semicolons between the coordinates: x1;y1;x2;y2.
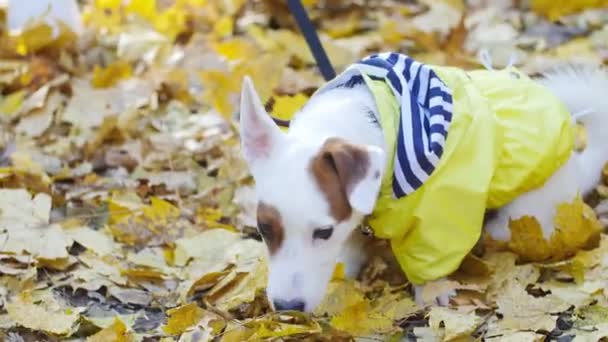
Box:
0;0;608;342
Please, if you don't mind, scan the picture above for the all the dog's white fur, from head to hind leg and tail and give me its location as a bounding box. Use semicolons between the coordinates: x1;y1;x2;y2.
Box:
241;68;608;311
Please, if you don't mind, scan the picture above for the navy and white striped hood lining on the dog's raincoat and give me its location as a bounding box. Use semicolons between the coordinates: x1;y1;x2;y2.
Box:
320;53;452;198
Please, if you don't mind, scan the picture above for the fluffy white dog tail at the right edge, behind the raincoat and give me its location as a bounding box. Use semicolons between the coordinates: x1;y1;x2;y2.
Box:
541;65;608;188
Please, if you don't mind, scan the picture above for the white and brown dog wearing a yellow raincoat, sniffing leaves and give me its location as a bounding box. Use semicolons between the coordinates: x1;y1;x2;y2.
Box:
240;53;608;312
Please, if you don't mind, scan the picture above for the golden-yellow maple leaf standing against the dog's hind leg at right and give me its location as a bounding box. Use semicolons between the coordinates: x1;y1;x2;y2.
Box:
509;197;601;261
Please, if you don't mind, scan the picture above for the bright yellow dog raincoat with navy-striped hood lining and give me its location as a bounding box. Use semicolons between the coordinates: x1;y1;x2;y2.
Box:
320;53;574;284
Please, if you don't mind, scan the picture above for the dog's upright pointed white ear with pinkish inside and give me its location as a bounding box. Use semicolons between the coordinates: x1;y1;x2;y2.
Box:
240;76;283;164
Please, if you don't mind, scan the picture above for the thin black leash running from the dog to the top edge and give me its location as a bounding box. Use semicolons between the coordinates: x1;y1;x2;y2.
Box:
270;0;336;127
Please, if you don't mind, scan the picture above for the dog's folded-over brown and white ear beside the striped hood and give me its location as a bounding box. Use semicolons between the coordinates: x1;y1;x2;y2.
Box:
321;138;385;215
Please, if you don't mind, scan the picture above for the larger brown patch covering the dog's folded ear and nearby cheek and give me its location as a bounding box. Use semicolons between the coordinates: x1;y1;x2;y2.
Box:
310;138;370;222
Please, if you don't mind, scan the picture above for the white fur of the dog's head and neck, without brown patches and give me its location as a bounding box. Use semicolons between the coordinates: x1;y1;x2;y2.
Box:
240;79;376;311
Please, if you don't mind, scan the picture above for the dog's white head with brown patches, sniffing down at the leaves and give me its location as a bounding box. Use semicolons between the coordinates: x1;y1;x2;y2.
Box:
240;78;384;311
